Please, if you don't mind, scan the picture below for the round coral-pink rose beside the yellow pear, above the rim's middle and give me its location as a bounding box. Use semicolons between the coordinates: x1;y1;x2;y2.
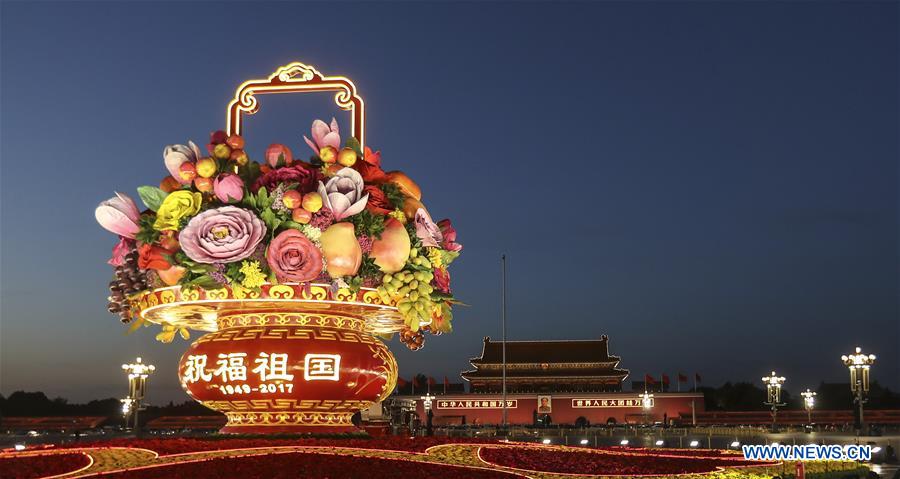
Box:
266;229;324;283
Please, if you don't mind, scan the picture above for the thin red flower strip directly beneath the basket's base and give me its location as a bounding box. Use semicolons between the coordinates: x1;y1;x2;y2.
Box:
55;436;495;456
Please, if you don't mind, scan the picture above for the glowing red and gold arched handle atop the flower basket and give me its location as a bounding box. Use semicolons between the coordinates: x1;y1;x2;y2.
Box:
227;62;366;148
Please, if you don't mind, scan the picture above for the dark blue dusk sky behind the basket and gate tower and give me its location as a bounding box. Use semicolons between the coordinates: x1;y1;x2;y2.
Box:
0;1;900;404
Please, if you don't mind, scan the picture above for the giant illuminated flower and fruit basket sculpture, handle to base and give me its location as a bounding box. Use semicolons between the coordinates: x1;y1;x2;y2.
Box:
96;63;462;433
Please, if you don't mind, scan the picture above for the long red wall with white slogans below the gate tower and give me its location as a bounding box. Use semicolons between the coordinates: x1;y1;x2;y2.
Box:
399;393;705;424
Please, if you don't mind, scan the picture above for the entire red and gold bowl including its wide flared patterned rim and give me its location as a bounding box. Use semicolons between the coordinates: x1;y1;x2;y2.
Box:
132;284;402;434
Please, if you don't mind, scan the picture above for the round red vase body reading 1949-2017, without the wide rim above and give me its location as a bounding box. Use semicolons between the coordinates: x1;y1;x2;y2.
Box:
179;310;397;434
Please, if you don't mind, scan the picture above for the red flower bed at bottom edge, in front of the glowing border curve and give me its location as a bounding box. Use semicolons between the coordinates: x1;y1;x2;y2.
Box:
103;453;522;479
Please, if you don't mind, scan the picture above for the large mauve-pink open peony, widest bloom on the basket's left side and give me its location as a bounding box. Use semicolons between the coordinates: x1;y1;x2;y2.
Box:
178;206;266;264
